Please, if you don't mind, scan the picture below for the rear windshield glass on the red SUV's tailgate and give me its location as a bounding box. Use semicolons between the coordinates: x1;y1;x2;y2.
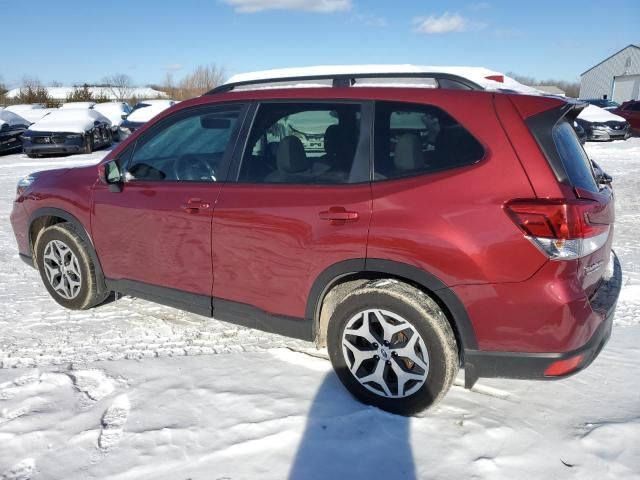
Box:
553;121;598;192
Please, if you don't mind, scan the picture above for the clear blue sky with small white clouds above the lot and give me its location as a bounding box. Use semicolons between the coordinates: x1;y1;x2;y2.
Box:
0;0;640;86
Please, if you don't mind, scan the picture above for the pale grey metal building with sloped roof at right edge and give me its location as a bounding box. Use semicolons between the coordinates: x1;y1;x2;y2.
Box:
580;45;640;103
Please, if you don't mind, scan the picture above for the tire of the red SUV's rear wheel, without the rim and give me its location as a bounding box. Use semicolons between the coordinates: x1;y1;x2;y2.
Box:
327;279;459;415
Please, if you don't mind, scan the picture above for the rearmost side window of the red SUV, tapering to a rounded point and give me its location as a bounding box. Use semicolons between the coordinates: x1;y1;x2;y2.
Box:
374;102;484;180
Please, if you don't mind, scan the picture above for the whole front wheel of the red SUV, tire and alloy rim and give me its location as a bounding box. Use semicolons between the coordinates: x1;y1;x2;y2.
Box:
35;223;109;310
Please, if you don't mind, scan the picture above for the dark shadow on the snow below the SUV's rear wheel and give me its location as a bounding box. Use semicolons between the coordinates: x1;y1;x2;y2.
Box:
289;372;416;480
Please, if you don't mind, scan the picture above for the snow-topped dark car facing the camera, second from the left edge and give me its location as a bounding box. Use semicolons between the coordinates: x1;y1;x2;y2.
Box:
22;108;112;157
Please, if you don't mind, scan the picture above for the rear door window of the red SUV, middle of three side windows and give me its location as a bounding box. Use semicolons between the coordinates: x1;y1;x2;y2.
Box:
238;103;369;184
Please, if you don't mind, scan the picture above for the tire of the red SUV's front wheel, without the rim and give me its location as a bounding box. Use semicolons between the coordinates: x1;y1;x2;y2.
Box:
34;222;110;310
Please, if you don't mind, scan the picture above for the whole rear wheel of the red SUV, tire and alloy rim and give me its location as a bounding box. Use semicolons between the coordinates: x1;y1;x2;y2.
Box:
327;279;459;415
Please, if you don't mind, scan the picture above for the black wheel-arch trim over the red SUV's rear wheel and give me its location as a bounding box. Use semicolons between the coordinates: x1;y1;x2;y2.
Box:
305;258;478;356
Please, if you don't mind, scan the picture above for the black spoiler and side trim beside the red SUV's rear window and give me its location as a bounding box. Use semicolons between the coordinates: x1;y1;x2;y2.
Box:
525;97;588;184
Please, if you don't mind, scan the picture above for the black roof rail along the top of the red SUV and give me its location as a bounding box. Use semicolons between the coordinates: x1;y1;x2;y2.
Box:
205;72;484;95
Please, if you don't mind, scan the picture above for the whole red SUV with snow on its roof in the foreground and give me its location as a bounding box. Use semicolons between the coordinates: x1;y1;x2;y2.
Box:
11;68;621;414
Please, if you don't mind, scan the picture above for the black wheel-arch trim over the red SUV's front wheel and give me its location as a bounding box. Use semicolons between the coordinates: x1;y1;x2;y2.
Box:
27;207;107;291
